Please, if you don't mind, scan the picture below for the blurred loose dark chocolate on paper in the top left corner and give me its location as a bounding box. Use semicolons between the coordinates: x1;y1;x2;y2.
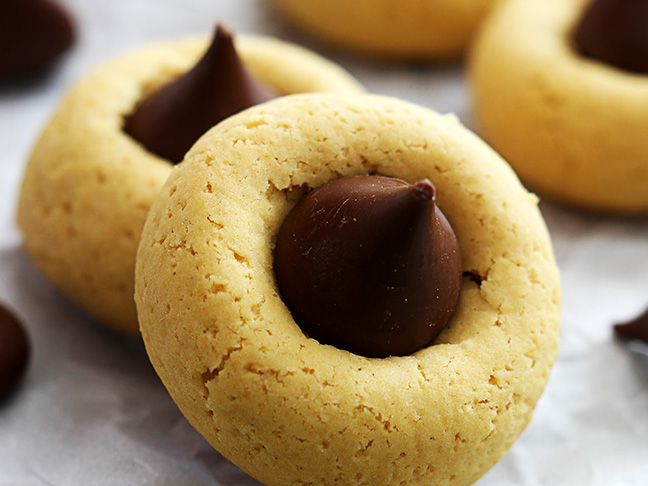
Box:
0;0;75;81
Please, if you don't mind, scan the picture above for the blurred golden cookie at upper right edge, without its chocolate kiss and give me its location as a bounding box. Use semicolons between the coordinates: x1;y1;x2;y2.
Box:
469;0;648;215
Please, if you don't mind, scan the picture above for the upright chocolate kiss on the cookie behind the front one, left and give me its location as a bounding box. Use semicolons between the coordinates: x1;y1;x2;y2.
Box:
124;25;275;163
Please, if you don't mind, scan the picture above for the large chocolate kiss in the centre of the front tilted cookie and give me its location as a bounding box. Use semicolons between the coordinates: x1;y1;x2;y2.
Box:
275;176;462;357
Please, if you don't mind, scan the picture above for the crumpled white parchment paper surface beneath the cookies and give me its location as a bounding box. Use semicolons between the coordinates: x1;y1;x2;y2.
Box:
0;0;648;486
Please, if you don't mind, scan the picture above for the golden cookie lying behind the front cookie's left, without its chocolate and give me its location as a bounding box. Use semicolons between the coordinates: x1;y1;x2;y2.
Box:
18;33;362;334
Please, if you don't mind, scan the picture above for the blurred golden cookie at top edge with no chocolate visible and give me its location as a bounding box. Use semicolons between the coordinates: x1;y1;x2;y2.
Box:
270;0;498;60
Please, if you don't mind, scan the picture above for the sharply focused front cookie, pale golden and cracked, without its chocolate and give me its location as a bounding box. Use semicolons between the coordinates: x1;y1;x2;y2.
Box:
135;94;560;486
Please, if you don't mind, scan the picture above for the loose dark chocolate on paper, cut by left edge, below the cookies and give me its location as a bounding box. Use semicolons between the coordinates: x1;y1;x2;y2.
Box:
0;305;30;400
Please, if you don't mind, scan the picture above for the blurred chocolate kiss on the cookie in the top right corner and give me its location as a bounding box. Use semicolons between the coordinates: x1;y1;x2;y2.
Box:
574;0;648;74
